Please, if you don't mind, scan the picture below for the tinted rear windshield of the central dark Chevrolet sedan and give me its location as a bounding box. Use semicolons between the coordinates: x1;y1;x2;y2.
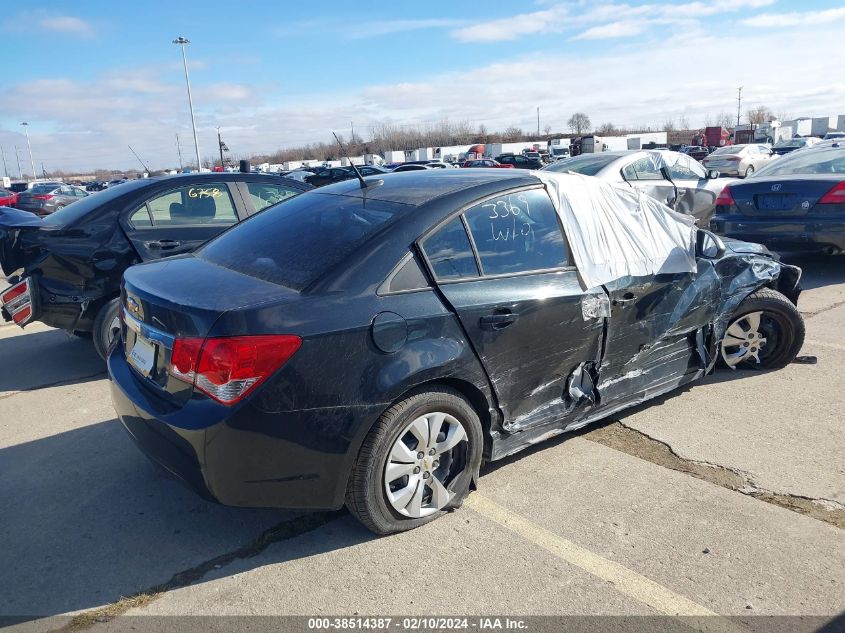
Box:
196;193;416;291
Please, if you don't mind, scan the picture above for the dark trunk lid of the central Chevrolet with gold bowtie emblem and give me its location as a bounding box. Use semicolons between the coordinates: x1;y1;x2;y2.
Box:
121;255;299;405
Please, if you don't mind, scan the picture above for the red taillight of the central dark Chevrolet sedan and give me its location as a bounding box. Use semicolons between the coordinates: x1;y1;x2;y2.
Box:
169;335;302;404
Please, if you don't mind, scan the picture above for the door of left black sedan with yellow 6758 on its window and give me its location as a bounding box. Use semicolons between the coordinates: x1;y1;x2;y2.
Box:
121;180;243;261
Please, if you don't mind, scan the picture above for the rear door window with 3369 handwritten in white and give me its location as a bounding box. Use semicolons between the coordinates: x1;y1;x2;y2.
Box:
465;189;568;275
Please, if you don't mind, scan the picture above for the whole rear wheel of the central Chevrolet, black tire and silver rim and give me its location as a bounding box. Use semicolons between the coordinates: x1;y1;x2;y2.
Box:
346;387;484;535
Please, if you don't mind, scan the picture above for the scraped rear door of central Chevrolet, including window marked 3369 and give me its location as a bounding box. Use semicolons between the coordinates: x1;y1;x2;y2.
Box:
421;188;606;430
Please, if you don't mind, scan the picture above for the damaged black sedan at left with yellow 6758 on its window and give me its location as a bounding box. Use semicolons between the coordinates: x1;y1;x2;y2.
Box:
0;173;311;358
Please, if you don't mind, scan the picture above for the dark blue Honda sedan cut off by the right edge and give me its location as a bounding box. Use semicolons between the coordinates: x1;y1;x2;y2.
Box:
710;143;845;254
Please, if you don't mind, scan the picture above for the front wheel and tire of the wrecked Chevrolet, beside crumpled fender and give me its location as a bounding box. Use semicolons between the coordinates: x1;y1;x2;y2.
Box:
719;288;804;369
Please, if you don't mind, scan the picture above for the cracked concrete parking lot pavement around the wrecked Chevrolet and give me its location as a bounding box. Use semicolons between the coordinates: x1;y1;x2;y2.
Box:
0;258;845;630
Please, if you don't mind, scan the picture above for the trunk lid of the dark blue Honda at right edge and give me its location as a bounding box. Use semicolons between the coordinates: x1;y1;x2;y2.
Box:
730;174;842;217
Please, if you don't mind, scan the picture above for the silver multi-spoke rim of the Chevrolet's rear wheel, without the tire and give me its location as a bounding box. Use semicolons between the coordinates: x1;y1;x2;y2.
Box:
384;411;468;519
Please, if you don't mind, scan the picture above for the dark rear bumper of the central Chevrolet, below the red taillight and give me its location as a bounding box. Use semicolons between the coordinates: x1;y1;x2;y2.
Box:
108;345;378;510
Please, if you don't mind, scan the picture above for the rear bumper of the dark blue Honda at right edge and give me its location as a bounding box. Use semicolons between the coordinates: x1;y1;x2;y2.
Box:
710;215;845;253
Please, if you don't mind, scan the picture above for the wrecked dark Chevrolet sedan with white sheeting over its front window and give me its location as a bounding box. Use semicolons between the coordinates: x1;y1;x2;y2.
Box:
108;169;804;534
